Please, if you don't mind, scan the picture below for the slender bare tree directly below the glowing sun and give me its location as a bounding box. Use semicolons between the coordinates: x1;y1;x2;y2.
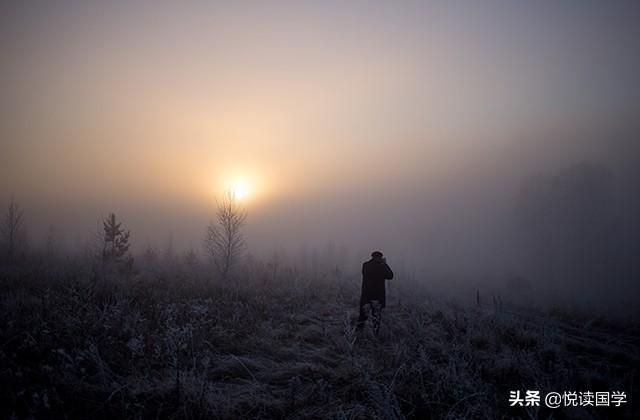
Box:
204;191;247;280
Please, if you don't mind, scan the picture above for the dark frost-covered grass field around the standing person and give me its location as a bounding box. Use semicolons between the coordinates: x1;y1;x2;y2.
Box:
0;263;640;419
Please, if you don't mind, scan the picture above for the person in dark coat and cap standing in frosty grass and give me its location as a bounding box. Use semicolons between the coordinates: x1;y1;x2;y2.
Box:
357;251;393;335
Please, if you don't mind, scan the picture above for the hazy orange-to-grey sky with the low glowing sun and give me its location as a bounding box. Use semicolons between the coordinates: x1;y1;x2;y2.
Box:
0;1;640;266
